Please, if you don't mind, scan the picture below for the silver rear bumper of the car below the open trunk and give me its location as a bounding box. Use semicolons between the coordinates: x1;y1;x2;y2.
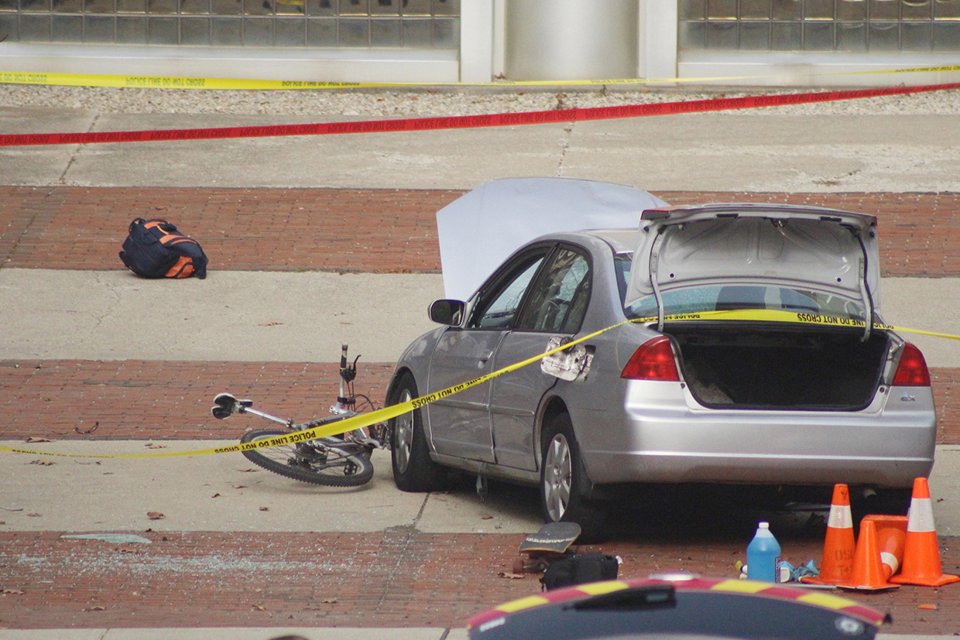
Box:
580;383;936;487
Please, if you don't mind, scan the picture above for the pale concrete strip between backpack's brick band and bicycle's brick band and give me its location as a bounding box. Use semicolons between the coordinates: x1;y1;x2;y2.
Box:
0;268;960;367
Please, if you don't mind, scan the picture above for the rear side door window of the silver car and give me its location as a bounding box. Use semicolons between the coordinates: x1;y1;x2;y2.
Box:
517;248;591;333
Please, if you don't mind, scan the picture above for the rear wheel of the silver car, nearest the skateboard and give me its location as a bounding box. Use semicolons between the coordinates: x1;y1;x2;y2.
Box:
540;413;607;542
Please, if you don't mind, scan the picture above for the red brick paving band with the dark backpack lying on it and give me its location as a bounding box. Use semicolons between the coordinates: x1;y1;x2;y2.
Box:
0;187;960;277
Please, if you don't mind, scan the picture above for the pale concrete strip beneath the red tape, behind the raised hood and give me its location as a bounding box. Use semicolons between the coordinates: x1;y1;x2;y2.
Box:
0;109;960;192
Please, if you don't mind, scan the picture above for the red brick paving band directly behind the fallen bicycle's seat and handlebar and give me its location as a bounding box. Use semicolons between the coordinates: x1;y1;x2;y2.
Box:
0;360;960;444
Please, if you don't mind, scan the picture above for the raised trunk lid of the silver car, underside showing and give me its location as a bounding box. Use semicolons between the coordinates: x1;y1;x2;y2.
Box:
625;204;880;313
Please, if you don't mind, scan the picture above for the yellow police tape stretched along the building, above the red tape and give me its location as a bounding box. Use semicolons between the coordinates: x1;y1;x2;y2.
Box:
0;65;960;91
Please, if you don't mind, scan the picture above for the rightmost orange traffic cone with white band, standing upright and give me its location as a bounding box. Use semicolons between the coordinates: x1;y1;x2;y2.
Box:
890;478;960;587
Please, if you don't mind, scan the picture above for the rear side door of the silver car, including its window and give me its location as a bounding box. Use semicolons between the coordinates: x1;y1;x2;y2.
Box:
490;245;593;470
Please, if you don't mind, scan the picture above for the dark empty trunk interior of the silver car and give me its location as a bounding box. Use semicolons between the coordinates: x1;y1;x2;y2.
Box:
664;322;890;411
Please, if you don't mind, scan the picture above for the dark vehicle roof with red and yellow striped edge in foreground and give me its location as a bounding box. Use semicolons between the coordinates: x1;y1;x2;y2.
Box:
467;578;887;640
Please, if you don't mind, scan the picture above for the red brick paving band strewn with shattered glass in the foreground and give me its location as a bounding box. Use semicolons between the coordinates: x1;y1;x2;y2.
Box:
0;514;960;635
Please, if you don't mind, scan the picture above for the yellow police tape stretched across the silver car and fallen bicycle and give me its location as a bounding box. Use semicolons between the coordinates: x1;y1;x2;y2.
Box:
0;309;960;459
